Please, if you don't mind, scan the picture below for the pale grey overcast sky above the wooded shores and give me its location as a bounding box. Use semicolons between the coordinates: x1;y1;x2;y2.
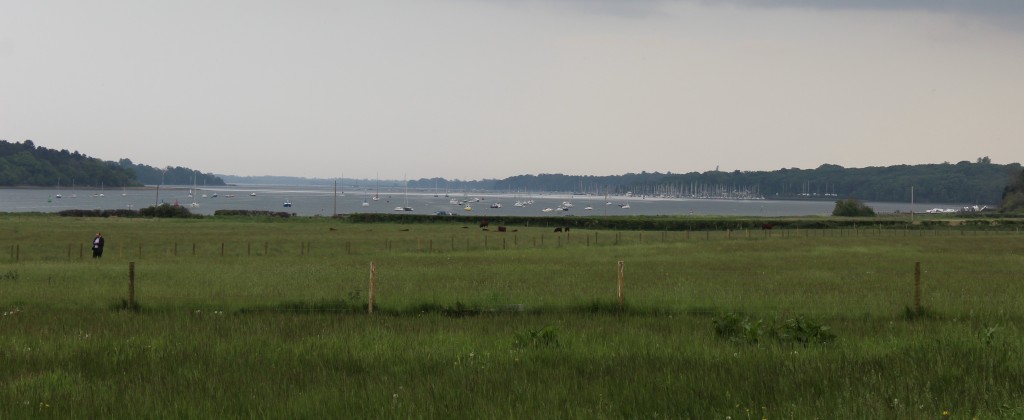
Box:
0;0;1024;179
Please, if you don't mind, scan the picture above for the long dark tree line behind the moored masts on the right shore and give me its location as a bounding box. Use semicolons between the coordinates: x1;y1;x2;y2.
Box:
410;157;1024;204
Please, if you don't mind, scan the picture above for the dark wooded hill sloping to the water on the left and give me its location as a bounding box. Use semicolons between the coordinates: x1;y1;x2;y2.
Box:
0;140;224;187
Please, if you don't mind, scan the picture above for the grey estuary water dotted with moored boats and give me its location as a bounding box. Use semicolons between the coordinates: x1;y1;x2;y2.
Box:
0;185;974;216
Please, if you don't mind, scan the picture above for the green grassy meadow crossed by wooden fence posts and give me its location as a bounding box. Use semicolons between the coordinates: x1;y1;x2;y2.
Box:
0;214;1024;419
